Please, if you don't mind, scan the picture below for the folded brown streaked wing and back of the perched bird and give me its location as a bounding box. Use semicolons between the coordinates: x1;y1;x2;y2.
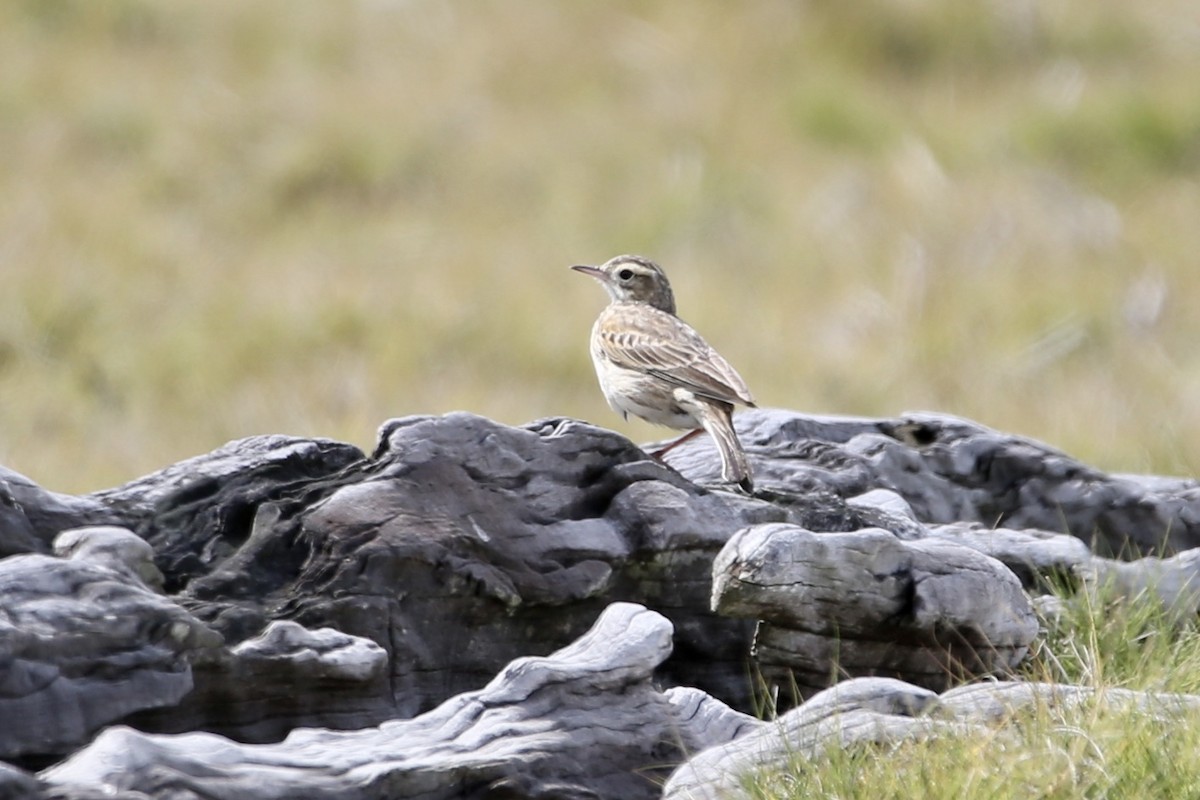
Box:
598;305;754;405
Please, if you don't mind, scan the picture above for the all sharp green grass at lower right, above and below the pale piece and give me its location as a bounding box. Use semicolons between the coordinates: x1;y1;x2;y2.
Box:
744;582;1200;800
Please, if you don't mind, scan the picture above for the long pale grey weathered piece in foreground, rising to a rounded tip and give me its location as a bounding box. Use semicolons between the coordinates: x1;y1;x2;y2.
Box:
40;603;720;800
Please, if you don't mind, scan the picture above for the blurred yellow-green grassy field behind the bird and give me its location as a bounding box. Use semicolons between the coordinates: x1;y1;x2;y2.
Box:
0;0;1200;492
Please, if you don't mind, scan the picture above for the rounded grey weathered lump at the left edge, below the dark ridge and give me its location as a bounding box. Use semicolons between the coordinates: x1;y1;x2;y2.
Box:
0;528;220;759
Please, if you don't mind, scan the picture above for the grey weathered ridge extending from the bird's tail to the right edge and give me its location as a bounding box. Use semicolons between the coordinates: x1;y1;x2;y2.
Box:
670;409;1200;557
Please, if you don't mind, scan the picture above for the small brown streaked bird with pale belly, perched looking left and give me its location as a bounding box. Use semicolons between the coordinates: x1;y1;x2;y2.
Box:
571;255;757;493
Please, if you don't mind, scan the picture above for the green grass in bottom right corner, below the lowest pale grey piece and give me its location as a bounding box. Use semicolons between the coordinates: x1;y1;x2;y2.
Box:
745;703;1200;800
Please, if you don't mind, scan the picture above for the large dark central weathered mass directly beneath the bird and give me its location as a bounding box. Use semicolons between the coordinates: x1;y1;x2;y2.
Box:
116;414;777;741
